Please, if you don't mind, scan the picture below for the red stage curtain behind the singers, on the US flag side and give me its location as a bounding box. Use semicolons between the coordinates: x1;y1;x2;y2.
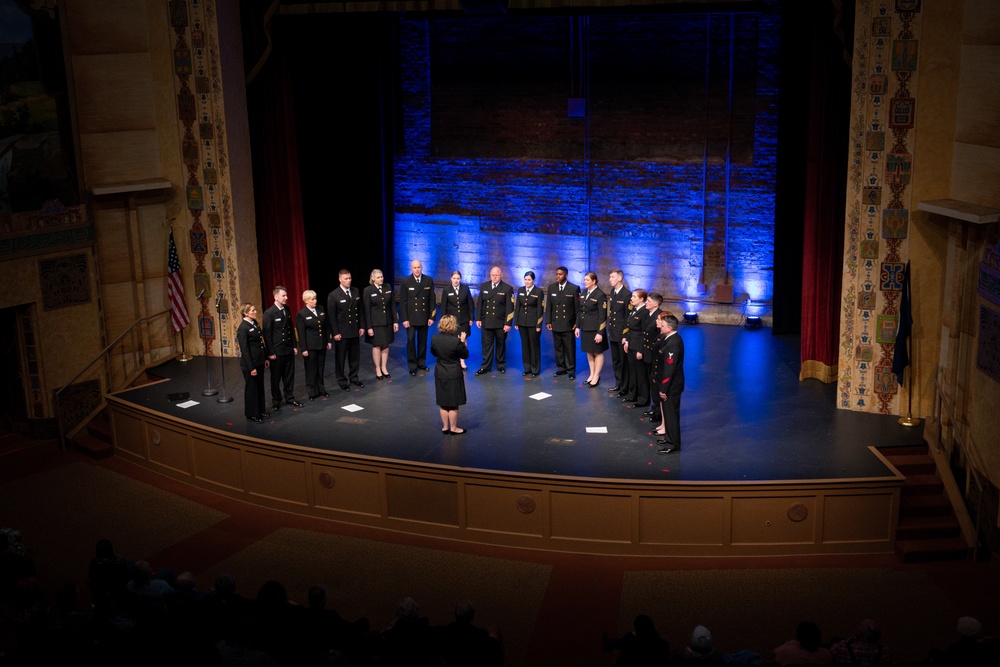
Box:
247;23;309;308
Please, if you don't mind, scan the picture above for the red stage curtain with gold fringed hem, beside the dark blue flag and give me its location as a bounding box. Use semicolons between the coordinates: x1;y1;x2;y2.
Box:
799;7;851;382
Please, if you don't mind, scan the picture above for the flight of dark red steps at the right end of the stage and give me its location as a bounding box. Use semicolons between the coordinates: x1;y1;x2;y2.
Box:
879;445;969;563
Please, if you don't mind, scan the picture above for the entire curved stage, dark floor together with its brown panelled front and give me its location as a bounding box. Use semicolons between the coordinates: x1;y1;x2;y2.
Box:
110;324;922;554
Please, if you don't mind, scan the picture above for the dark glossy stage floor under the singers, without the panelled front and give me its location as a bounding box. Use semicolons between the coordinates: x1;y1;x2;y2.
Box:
117;324;923;482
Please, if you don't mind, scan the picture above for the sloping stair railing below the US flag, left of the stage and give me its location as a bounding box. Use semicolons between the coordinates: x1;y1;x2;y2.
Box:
53;309;176;449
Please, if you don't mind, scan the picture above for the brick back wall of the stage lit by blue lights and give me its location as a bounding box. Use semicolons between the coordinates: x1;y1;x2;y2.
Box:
394;13;778;301
